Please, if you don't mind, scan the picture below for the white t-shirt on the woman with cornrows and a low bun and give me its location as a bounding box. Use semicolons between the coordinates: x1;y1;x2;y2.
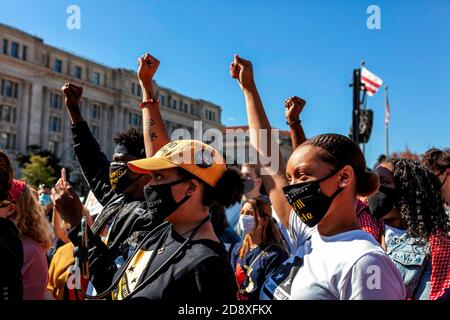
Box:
260;213;405;300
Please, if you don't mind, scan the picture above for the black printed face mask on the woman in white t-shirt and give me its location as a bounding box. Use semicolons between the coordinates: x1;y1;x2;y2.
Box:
283;169;343;228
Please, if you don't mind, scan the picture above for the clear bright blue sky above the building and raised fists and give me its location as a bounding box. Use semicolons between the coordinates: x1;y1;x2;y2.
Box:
0;0;450;165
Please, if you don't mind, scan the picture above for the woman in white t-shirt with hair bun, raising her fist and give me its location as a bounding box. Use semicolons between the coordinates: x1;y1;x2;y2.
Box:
230;55;405;300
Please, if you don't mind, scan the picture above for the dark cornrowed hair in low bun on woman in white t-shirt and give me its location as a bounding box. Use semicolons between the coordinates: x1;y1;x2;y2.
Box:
302;133;379;196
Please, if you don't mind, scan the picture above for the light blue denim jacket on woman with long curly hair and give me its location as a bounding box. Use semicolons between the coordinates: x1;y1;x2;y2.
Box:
386;233;431;300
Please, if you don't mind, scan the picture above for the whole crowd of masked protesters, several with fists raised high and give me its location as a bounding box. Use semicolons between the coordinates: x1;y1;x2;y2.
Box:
0;54;450;302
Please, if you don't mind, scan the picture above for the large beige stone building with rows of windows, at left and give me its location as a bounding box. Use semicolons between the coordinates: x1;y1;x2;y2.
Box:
0;24;224;190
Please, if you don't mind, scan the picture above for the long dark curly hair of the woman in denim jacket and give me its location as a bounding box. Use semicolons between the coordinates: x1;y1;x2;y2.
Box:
392;158;450;239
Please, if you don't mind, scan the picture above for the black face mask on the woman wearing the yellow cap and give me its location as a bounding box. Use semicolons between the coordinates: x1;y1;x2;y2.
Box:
144;179;191;220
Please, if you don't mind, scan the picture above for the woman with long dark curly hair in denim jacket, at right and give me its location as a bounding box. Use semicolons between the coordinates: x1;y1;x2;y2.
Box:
369;159;450;300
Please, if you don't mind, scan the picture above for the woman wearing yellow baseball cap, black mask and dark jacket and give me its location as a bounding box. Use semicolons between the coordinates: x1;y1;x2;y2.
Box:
79;140;244;301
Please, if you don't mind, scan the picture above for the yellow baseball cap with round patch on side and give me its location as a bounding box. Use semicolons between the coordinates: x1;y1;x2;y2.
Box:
128;140;227;187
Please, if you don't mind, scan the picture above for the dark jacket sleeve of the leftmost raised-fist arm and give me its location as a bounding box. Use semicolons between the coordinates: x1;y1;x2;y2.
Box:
72;121;115;206
